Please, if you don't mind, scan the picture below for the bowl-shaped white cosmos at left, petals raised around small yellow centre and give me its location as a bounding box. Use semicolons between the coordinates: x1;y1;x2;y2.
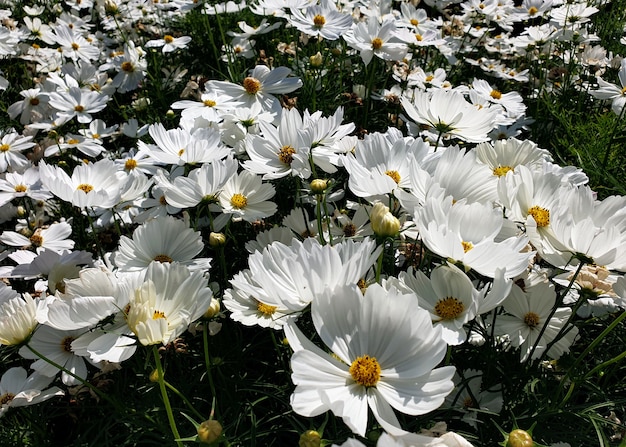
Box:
39;158;126;208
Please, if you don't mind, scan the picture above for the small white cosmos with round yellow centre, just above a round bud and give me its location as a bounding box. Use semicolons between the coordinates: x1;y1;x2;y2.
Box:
219;171;277;222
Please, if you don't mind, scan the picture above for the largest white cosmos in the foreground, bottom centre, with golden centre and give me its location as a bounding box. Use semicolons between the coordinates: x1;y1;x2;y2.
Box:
285;284;454;436
